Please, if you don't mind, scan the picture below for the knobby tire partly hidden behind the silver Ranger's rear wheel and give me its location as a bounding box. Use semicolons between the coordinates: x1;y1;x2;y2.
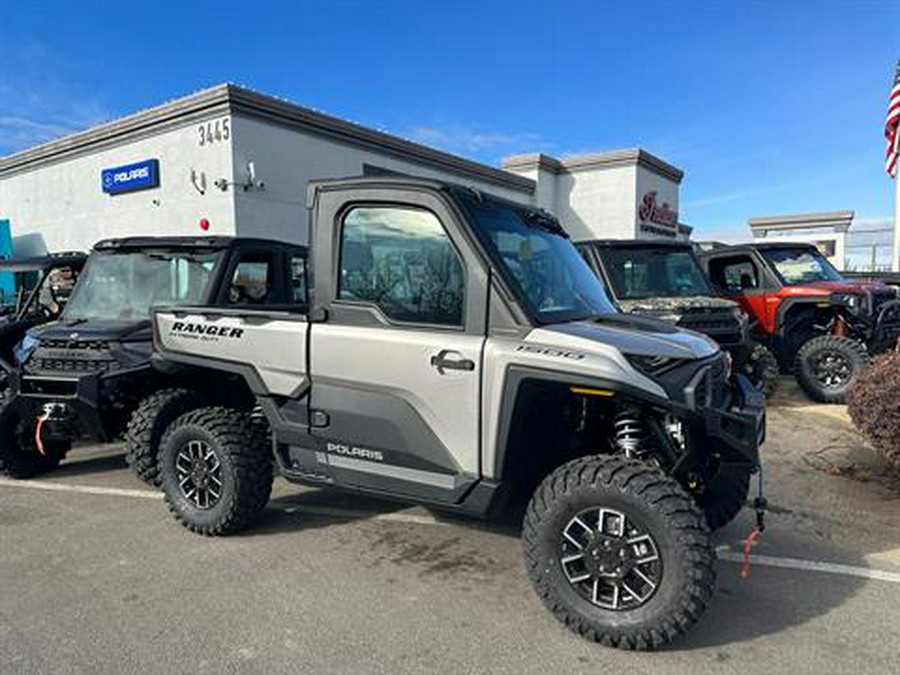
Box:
125;389;205;486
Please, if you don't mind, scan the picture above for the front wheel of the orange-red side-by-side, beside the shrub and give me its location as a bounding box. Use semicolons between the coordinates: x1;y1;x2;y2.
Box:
794;335;870;403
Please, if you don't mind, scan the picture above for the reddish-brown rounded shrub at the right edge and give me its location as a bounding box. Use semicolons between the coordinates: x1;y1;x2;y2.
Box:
847;352;900;471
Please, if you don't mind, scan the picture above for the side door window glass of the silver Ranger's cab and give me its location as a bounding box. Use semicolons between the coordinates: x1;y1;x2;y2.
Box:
338;207;465;326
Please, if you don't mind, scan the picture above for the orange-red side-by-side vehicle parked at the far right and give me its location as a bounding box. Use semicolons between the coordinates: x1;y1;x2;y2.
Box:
701;241;900;403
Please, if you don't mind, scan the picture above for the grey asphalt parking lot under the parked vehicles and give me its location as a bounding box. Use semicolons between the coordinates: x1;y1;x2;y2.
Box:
0;386;900;673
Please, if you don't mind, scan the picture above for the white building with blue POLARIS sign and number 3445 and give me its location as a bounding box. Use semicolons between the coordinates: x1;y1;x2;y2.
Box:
0;84;690;255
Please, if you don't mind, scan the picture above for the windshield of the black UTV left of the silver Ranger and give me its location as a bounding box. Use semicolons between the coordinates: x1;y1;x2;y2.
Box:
62;250;222;321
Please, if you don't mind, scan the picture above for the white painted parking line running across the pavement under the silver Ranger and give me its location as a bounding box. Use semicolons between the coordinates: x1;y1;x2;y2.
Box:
0;478;900;584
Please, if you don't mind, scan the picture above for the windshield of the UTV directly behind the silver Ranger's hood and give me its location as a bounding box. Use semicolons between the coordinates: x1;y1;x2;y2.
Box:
599;246;713;300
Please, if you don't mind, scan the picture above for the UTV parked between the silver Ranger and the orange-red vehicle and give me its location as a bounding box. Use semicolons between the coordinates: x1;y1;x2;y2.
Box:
577;239;779;396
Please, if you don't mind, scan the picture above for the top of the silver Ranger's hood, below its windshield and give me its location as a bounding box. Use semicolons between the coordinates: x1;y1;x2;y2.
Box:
543;314;719;359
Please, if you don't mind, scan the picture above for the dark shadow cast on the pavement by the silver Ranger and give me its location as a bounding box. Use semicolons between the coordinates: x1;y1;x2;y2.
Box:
256;490;878;648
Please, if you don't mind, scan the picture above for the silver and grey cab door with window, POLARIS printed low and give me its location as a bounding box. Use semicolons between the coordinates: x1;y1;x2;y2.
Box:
309;188;487;503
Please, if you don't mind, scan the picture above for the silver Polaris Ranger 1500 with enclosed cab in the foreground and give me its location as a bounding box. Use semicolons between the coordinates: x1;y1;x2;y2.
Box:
154;178;765;649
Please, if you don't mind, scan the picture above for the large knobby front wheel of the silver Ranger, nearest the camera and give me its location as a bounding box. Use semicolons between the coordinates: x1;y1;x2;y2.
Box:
522;457;715;649
